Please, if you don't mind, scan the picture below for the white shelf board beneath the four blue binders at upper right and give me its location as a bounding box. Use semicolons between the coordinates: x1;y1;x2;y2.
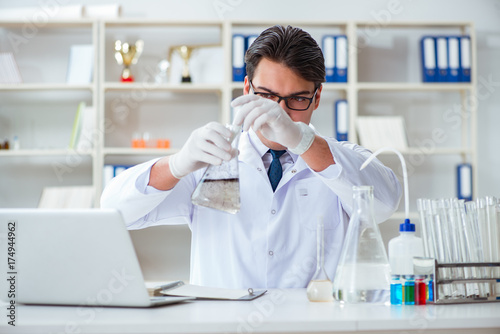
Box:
356;82;473;91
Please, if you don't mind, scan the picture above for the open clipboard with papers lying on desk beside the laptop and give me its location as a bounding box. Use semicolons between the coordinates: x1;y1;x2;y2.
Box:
154;281;267;300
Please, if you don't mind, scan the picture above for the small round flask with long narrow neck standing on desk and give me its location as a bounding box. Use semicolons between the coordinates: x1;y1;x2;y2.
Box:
306;217;333;302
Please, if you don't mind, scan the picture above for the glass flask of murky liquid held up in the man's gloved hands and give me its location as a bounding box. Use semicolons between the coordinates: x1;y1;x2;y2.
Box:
191;124;241;214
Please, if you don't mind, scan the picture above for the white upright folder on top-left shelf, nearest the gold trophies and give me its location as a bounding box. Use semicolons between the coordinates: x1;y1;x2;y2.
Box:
66;44;94;84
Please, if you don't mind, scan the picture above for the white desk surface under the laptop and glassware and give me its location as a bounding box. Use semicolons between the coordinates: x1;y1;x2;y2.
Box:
0;289;500;334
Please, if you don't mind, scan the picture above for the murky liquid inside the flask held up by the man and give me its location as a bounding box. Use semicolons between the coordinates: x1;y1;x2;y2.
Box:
191;179;240;214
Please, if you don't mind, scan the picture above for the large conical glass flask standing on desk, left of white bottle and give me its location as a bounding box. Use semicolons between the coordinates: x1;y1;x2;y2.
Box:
333;186;391;303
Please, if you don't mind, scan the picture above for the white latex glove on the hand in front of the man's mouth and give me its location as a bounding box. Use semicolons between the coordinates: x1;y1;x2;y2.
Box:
231;94;314;155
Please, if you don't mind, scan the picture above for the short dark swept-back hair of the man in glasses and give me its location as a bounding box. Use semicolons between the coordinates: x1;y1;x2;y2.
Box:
245;25;325;88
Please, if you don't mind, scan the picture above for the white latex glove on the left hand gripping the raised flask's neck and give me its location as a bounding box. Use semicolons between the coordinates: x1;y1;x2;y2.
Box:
169;122;237;179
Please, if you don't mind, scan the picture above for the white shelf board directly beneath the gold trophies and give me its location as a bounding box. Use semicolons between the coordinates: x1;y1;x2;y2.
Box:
104;82;222;93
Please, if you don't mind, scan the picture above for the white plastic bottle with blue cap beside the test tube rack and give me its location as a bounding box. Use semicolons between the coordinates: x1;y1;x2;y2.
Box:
389;219;424;275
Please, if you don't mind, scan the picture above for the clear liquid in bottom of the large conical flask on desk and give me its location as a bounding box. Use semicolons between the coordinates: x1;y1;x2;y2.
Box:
334;263;391;303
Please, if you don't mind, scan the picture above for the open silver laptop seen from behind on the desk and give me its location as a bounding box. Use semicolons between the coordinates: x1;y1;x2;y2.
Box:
0;209;194;307
